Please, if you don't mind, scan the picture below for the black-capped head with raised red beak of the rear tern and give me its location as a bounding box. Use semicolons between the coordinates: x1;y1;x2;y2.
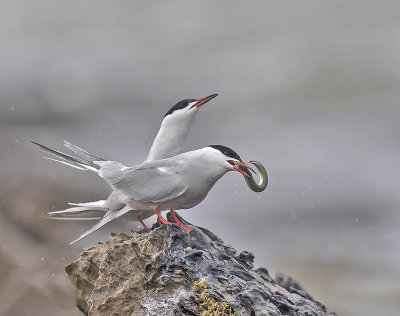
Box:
164;94;218;120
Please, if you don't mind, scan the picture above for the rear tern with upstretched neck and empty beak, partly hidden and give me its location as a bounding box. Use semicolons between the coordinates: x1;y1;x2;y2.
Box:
32;94;218;229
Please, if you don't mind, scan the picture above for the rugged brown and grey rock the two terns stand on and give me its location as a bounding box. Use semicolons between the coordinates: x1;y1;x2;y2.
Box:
66;214;335;316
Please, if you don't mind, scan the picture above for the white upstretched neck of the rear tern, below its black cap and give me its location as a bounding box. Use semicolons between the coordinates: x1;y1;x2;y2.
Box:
146;115;195;161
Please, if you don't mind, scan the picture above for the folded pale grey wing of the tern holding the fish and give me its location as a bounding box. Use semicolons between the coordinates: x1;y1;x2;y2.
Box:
108;163;187;203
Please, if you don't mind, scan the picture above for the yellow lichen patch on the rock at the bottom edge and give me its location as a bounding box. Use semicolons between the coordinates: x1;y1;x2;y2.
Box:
192;280;237;316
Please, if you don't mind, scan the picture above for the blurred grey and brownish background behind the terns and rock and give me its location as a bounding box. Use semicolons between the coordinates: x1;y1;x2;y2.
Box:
0;0;400;316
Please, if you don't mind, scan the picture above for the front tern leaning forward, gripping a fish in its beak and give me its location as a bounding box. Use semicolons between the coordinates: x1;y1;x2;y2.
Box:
71;145;251;244
